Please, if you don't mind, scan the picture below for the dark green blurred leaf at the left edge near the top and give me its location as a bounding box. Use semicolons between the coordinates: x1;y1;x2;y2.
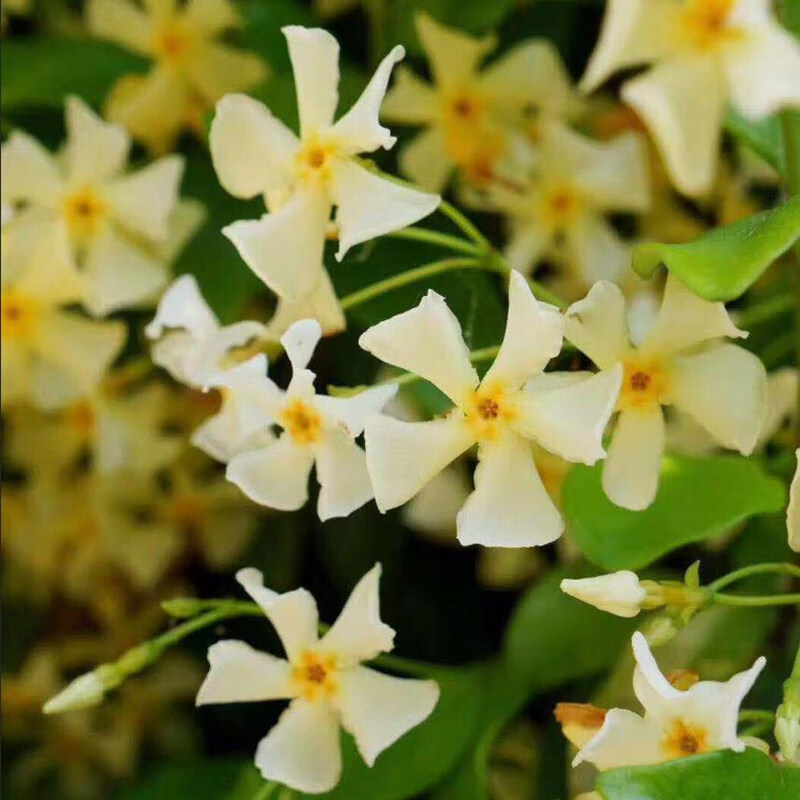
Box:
0;38;147;111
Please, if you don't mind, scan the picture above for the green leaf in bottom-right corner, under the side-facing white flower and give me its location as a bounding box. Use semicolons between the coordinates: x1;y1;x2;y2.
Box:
597;749;800;800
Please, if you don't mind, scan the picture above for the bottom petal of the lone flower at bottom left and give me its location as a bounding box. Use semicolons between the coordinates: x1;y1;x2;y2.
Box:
256;700;342;794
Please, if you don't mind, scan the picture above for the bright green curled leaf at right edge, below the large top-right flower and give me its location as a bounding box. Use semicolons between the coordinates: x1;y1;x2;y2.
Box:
633;195;800;301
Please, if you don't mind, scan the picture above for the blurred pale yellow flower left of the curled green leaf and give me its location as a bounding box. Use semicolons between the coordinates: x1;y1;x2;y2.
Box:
476;122;650;294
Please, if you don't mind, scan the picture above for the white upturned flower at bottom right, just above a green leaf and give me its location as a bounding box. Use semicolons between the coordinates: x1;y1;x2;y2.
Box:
573;632;766;770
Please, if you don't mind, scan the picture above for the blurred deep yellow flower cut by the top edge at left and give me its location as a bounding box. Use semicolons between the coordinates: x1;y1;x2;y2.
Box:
87;0;267;153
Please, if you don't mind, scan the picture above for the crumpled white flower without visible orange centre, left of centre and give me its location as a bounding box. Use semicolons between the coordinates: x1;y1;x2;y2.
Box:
145;275;274;389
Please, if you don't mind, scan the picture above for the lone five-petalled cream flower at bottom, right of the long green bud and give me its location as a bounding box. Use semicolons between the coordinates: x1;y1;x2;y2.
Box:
197;564;439;794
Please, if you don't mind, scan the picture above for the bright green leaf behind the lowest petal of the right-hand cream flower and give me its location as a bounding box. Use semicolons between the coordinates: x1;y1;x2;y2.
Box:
563;456;785;570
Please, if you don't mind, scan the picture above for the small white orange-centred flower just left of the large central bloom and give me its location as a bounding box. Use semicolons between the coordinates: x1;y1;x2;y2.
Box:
223;319;397;520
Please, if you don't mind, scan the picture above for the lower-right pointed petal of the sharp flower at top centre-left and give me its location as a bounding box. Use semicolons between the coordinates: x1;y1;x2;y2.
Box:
332;160;441;261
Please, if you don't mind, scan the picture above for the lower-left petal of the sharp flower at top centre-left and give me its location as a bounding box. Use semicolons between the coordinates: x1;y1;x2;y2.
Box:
222;184;330;299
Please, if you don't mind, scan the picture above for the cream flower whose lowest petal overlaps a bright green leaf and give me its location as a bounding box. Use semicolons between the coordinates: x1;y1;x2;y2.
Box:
566;274;767;510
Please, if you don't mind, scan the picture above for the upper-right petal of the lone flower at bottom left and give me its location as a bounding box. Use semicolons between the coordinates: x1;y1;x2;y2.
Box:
320;564;395;667
